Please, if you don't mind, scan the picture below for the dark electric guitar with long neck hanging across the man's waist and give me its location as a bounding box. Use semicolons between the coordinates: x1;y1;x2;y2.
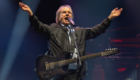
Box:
36;48;120;80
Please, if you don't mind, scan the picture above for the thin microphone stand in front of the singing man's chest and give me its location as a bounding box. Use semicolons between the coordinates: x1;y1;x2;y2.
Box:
70;25;82;80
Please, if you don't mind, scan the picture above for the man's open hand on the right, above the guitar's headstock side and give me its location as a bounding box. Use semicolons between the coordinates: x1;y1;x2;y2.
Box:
108;8;123;20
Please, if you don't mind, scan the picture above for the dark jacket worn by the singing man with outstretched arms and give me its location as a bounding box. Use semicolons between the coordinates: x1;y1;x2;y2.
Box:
29;15;111;78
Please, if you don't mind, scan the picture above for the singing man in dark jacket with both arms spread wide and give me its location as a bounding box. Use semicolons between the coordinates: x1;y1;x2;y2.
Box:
19;2;123;80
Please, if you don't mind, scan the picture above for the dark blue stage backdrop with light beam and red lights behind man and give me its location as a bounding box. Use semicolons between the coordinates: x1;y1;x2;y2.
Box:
0;0;140;80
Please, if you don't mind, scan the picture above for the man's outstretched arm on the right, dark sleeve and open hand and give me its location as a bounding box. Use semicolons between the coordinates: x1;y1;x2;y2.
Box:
84;8;123;39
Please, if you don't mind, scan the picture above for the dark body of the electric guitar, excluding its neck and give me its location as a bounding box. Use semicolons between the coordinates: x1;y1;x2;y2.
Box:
36;55;68;80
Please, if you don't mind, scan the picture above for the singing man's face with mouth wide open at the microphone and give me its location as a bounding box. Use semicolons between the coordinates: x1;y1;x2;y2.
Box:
59;7;72;25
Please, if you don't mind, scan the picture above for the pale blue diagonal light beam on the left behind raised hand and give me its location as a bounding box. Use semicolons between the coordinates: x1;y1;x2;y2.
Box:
0;0;40;80
